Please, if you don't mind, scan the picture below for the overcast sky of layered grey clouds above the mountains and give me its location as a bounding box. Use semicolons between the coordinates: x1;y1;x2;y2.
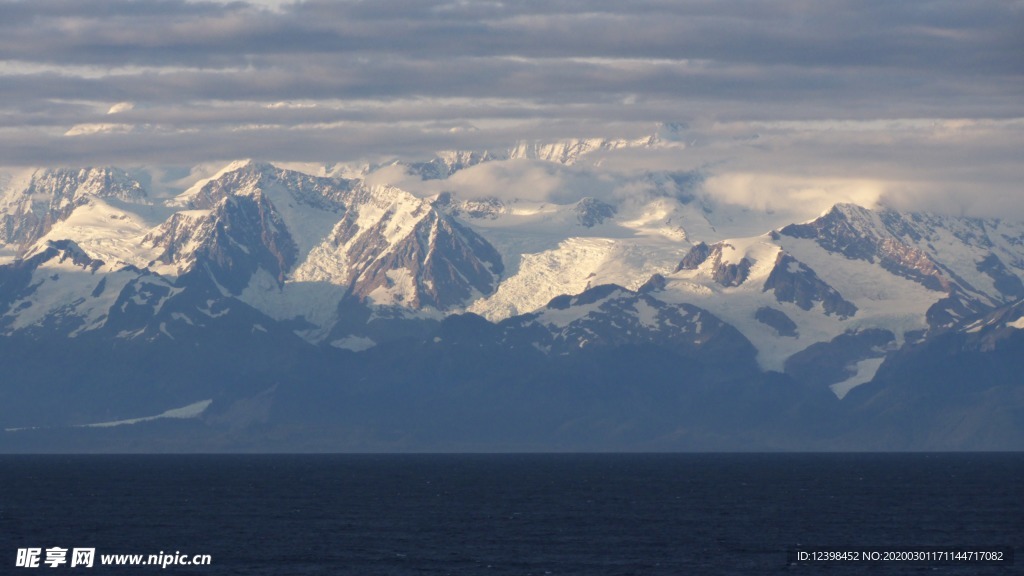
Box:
0;0;1024;215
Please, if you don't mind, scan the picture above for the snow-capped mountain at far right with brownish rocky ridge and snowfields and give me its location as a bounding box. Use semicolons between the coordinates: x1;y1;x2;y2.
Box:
647;205;1024;395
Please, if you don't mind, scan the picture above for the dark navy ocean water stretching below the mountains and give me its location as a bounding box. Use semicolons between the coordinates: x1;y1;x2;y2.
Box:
0;454;1024;576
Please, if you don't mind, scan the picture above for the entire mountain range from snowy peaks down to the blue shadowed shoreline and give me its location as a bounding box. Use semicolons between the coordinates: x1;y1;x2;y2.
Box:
0;136;1024;451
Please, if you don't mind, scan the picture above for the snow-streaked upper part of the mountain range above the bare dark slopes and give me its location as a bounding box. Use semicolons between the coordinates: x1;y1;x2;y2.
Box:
0;136;1024;448
